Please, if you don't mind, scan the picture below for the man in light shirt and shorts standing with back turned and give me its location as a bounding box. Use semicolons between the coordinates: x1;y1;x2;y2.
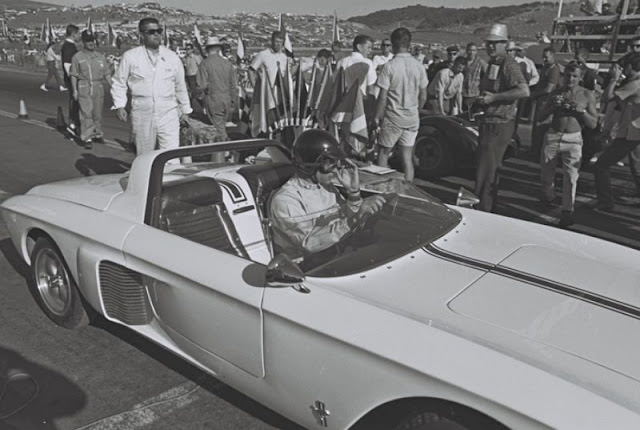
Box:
373;27;429;181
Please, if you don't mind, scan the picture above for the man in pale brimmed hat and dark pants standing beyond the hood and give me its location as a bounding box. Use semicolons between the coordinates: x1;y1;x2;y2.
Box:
475;24;529;212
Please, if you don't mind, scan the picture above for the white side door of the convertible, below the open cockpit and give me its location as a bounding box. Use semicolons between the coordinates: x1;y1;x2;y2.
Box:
124;225;266;377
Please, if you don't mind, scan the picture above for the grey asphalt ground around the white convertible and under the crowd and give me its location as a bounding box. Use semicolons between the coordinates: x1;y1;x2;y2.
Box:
0;64;640;430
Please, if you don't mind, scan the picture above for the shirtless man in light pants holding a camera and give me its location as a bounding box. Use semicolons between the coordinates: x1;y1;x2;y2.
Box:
540;62;598;227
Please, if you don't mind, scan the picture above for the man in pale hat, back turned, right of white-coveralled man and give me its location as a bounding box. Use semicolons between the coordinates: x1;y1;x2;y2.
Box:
196;36;238;142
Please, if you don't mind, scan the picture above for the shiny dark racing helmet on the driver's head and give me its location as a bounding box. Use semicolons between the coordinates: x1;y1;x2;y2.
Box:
293;128;347;176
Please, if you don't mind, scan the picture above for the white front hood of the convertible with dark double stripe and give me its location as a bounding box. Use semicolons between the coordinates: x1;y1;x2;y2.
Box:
314;210;640;394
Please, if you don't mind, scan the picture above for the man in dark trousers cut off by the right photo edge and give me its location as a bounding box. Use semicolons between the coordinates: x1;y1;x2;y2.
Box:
594;53;640;210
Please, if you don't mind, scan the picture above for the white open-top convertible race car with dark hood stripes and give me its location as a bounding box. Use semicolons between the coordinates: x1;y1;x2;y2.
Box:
1;140;640;430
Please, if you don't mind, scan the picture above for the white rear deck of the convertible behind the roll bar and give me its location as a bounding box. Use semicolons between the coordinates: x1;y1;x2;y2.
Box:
27;174;123;210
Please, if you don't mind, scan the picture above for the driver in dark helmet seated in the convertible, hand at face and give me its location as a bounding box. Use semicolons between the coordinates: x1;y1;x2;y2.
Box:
269;129;385;258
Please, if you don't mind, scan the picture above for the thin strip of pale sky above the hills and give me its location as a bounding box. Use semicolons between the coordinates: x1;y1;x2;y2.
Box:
36;0;534;19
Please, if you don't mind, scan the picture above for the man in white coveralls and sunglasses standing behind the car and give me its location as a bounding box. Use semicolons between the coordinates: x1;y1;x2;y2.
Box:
111;18;192;155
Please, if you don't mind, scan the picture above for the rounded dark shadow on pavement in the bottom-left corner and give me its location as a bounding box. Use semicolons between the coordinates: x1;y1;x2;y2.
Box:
0;347;87;430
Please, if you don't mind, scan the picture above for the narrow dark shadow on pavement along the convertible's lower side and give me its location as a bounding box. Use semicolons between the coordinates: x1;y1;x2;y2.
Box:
92;317;303;430
